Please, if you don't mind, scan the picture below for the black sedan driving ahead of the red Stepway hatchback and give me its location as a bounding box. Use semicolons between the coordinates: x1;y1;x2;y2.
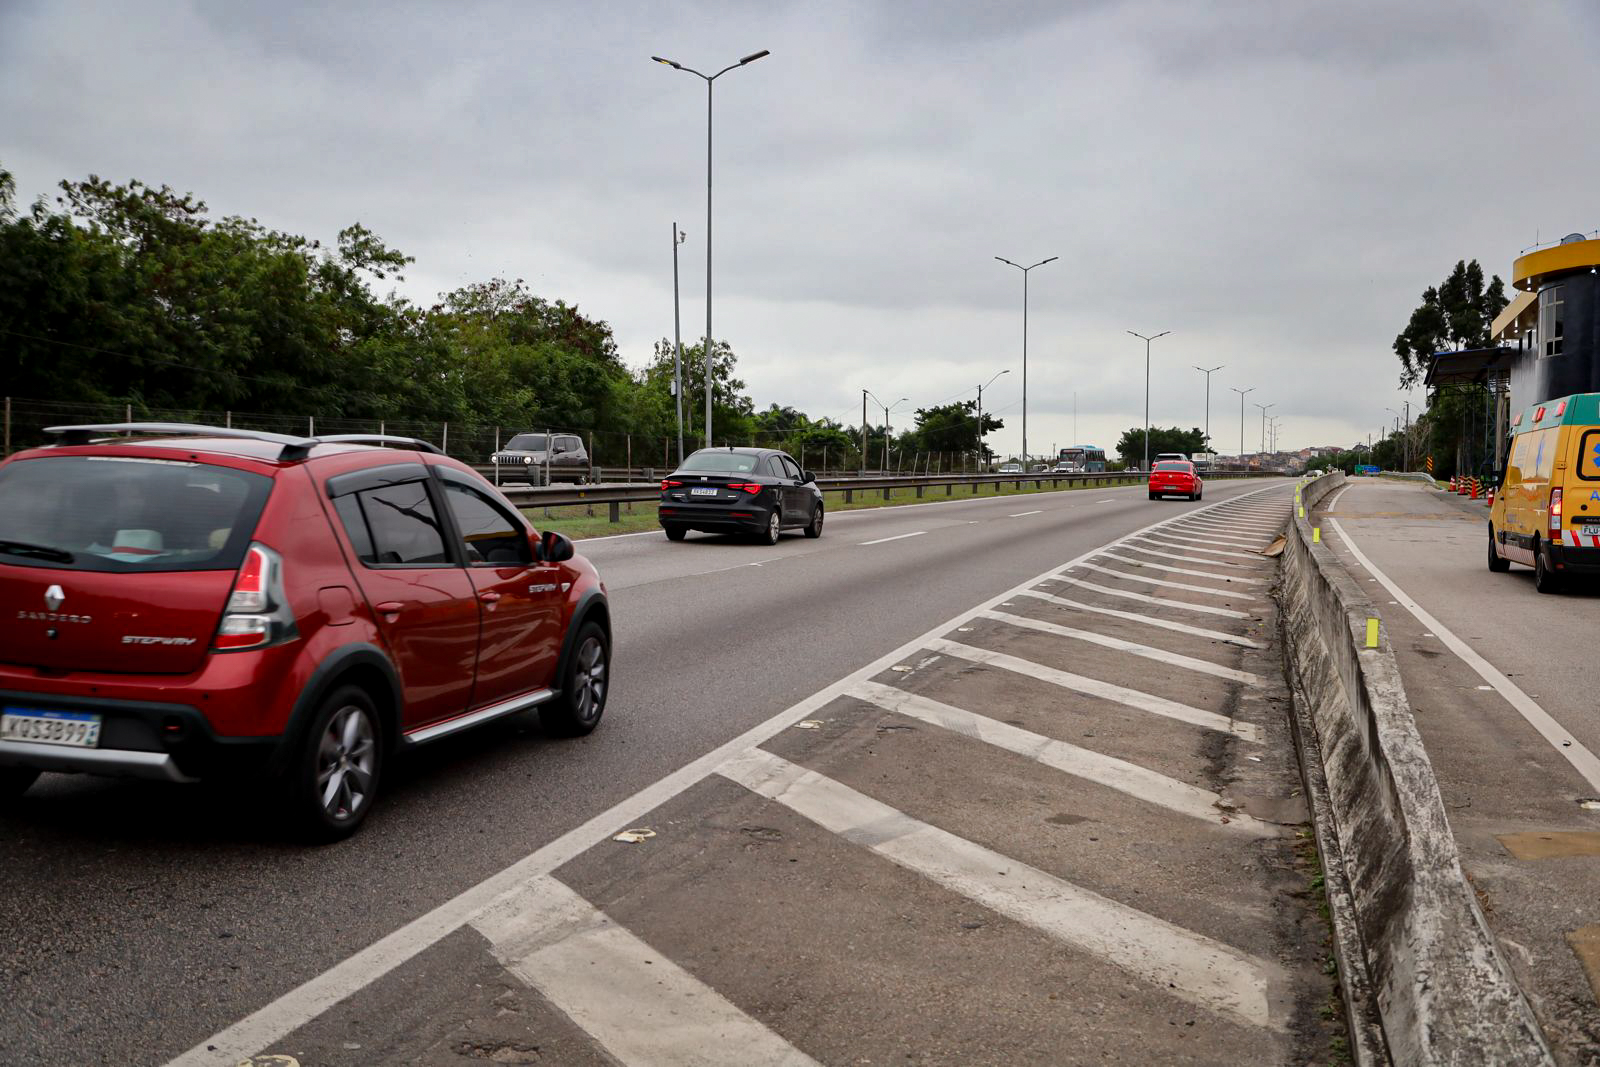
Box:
658;448;822;544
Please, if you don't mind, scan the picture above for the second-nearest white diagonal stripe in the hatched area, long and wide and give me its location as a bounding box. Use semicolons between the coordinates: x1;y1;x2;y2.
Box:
718;749;1282;1029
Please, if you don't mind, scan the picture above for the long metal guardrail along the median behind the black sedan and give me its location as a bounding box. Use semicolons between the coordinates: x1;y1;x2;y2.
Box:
501;470;1272;522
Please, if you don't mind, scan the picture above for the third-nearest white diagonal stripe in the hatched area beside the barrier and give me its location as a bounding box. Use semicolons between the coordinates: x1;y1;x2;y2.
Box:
850;681;1283;837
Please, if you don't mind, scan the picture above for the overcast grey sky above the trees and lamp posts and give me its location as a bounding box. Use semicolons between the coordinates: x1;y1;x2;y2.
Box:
0;0;1600;453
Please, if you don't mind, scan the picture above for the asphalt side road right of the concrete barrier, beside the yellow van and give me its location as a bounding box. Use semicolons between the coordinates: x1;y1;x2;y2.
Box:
1317;480;1600;1064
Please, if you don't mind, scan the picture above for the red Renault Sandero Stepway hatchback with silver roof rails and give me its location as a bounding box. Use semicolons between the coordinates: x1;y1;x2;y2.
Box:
0;422;611;838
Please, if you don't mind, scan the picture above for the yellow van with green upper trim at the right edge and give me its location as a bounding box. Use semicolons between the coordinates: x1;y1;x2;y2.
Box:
1490;394;1600;593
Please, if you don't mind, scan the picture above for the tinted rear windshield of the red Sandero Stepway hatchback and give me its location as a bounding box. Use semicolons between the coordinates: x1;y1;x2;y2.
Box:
0;456;272;571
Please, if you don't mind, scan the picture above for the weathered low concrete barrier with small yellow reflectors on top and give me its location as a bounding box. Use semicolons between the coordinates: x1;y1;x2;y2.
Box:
1283;474;1552;1064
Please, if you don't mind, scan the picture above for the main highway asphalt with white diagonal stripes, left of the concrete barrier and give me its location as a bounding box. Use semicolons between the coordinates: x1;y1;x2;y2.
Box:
0;482;1330;1064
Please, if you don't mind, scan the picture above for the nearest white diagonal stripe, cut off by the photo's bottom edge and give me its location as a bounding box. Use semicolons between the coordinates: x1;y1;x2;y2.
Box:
472;875;816;1067
